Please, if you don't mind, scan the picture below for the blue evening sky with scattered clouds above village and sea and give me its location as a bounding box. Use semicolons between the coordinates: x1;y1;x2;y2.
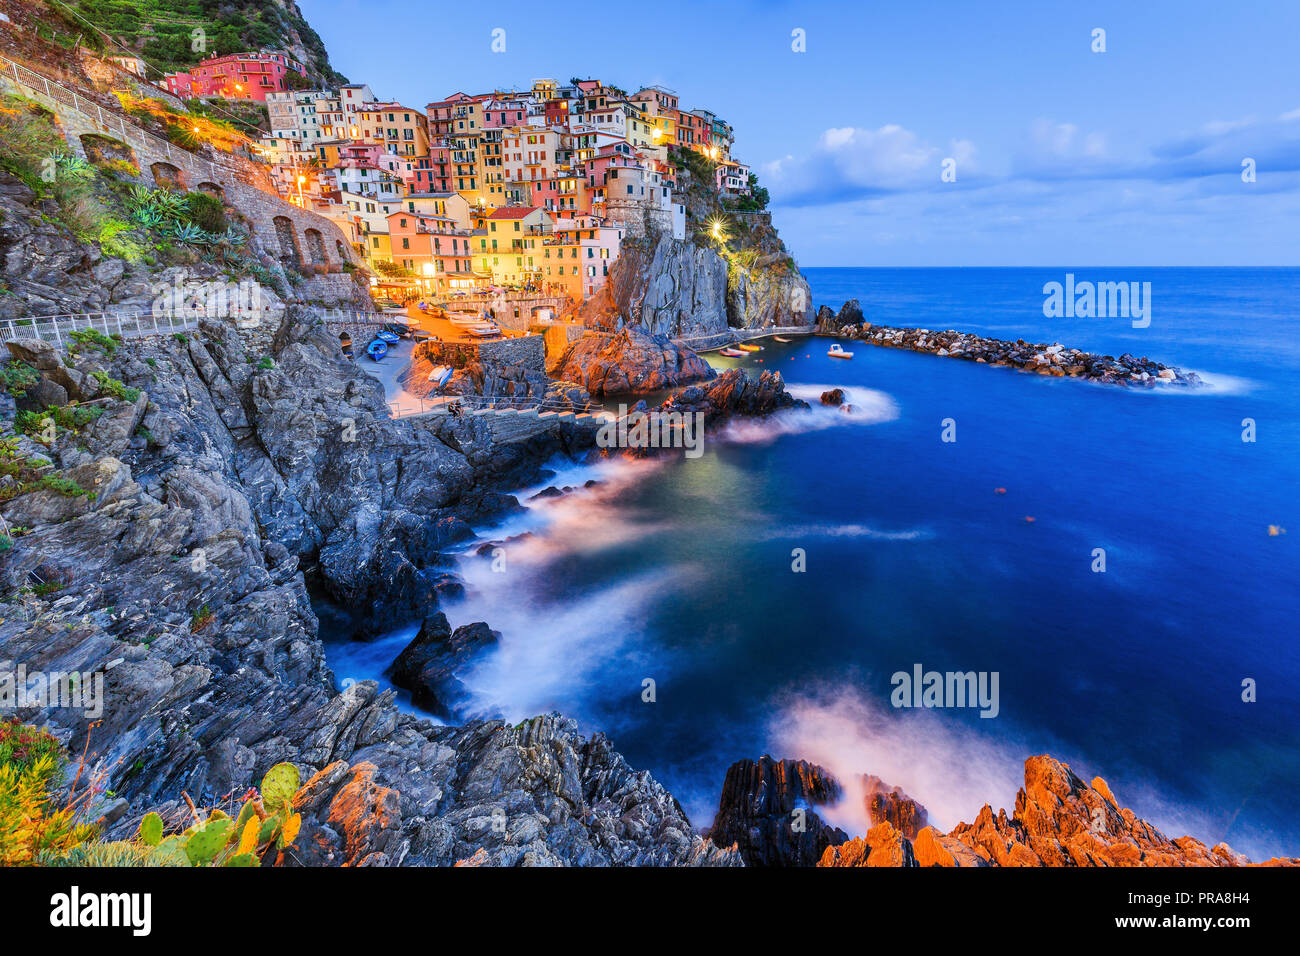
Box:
299;0;1300;267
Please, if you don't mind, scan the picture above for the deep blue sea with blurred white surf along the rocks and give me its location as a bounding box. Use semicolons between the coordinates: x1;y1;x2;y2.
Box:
329;267;1300;858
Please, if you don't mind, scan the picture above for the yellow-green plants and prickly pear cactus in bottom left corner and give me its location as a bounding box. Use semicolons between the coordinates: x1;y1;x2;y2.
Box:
0;721;302;866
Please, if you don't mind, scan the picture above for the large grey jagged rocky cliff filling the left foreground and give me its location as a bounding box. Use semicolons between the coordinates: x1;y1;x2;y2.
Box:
0;307;738;865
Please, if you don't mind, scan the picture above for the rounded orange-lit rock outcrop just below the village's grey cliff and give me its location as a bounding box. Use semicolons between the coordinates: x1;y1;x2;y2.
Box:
554;326;715;397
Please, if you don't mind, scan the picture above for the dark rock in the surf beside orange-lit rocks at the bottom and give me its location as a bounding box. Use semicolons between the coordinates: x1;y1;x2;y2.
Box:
709;756;848;866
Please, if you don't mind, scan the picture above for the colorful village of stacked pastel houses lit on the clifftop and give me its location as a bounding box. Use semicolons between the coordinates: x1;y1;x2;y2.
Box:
160;51;751;310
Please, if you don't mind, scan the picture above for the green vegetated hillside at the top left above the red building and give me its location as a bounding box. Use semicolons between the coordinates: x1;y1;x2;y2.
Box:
42;0;346;83
